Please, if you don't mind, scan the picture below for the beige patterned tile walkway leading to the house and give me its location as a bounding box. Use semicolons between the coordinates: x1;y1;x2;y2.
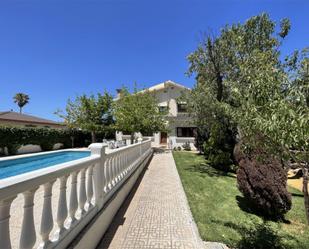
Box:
98;152;203;249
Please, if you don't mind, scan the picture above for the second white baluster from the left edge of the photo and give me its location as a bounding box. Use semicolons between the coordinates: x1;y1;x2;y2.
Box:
19;187;38;249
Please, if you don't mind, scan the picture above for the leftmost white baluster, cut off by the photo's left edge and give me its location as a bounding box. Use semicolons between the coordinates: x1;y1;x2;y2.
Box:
0;196;16;249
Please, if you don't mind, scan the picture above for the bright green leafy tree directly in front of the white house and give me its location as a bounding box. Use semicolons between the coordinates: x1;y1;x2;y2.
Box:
114;88;166;142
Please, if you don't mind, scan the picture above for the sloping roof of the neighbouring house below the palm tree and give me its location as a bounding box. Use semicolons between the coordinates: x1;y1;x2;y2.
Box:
0;111;64;126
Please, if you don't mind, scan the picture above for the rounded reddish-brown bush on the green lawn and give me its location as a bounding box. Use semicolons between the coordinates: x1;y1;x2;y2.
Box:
235;145;292;219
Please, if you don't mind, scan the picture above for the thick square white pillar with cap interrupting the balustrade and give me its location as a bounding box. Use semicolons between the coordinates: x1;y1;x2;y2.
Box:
89;143;107;209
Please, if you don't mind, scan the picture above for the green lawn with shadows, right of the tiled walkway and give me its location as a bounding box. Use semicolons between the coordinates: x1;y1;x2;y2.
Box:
173;152;309;249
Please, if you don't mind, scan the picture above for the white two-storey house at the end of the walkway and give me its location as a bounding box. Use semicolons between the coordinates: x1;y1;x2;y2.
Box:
116;80;196;148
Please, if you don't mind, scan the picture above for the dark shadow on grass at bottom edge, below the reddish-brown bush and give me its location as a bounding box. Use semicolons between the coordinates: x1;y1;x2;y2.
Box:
212;221;303;249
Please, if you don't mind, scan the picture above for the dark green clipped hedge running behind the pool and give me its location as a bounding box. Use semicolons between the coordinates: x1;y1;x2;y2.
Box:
0;127;114;155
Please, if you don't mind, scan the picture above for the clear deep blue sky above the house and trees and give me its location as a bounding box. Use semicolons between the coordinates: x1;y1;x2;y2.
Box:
0;0;309;120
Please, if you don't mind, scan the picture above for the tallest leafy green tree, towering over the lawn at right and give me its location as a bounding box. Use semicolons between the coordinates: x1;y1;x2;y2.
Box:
189;14;309;220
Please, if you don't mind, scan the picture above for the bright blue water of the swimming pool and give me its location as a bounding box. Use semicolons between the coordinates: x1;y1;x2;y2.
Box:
0;151;90;179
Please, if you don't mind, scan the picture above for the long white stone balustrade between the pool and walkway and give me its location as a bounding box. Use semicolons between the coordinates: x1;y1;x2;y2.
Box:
0;141;152;249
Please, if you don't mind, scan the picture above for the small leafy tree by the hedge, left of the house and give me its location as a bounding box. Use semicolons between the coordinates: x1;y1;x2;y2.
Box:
56;92;114;143
